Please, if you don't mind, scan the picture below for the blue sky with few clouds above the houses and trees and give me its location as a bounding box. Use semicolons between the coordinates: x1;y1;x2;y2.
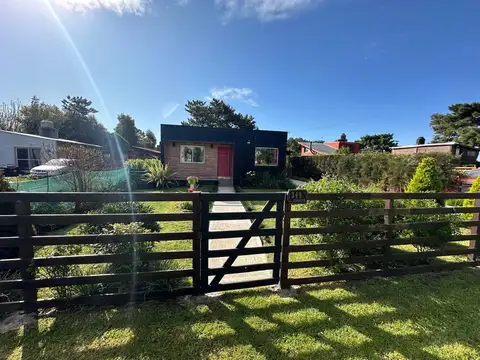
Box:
0;0;480;145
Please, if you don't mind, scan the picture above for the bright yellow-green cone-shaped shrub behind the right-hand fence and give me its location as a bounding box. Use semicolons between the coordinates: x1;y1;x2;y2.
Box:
405;157;444;192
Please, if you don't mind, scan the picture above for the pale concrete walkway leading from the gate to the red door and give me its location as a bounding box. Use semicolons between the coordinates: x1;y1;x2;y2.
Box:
208;186;272;284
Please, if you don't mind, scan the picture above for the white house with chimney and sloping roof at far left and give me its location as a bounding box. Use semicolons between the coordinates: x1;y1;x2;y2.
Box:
0;121;101;172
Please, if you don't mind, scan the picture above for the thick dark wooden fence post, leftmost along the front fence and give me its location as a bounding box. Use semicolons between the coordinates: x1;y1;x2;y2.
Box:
15;200;37;313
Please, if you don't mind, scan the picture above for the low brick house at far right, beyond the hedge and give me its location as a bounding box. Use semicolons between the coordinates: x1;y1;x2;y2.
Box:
392;142;480;164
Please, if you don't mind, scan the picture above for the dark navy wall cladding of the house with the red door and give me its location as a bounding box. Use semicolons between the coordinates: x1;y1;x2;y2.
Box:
160;124;288;183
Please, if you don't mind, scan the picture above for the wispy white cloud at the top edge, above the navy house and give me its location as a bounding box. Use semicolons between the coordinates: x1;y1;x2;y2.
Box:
215;0;323;21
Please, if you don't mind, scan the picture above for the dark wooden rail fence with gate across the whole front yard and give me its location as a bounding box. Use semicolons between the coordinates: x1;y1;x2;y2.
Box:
0;192;480;312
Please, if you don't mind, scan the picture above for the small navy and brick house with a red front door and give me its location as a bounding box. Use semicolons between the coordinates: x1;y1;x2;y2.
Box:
160;124;287;183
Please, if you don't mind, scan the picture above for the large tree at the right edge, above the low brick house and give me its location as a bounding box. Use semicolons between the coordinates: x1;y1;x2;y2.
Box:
430;102;480;146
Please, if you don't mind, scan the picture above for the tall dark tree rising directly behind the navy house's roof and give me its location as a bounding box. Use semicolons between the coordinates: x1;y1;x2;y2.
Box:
182;99;257;129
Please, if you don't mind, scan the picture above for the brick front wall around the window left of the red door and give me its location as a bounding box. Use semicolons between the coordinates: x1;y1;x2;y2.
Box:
163;141;228;180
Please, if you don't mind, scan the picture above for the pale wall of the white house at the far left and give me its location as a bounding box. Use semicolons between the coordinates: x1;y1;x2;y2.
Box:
0;131;56;168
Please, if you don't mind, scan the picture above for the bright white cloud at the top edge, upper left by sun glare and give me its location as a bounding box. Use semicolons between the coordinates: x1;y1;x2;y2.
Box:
47;0;151;16
